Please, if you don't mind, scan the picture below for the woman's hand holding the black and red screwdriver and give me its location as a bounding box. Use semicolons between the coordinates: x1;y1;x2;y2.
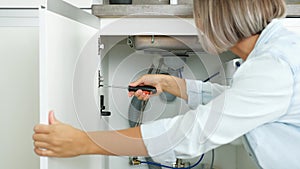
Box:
128;74;167;100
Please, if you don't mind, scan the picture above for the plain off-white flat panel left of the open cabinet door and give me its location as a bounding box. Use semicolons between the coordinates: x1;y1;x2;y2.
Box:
0;27;39;169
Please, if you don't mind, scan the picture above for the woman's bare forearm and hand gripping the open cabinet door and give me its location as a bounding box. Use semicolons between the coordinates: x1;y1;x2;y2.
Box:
33;112;148;157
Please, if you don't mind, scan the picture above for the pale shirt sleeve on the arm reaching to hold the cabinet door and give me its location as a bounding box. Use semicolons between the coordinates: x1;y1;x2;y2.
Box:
141;56;294;163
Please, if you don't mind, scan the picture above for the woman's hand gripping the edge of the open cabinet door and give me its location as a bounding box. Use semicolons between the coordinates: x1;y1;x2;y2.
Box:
33;112;93;157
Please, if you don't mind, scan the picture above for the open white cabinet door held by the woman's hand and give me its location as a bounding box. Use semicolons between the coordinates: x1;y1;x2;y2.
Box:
39;0;103;169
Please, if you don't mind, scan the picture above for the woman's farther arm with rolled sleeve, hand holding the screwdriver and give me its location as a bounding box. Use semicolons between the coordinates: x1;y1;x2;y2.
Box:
129;75;228;108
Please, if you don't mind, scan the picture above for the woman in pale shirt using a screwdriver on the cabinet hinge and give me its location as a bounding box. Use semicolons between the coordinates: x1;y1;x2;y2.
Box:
33;0;300;169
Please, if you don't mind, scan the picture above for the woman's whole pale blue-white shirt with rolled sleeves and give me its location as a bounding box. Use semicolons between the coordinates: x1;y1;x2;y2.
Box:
141;19;300;169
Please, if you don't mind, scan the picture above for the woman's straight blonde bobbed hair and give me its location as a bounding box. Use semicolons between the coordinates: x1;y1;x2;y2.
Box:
194;0;286;54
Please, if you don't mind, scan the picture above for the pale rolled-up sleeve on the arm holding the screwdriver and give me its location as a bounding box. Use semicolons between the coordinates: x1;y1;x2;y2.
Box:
185;79;228;109
